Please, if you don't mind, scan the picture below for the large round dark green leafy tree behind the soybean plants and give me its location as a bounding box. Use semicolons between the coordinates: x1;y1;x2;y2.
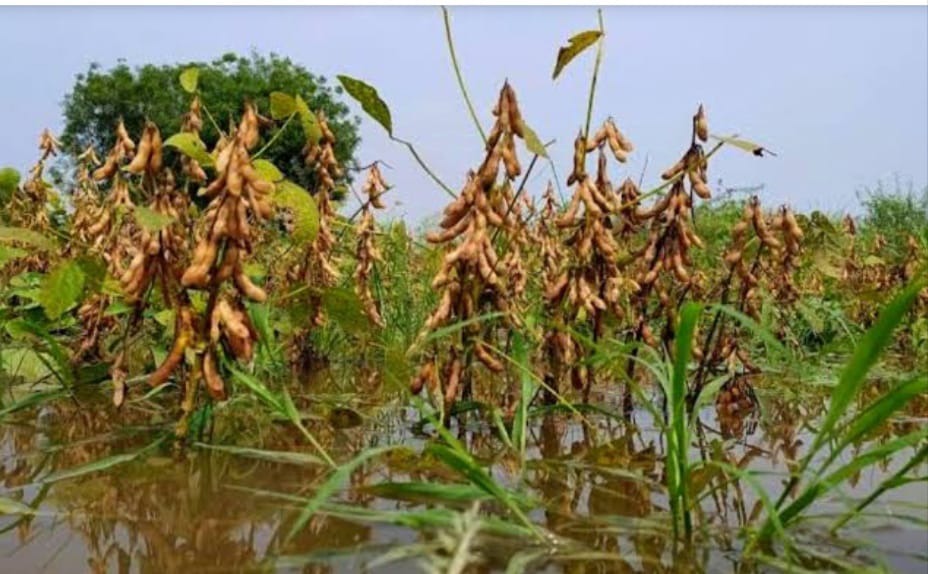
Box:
61;52;360;194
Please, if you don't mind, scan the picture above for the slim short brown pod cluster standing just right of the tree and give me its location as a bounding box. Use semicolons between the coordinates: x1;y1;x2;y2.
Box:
354;164;387;327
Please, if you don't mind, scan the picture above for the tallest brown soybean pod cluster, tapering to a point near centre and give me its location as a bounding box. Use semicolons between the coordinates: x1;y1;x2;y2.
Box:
412;83;524;412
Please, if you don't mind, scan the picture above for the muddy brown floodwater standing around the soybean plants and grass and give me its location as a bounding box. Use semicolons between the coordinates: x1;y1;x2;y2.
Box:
0;376;928;574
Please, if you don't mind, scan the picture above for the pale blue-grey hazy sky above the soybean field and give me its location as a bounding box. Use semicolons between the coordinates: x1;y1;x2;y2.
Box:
0;6;928;221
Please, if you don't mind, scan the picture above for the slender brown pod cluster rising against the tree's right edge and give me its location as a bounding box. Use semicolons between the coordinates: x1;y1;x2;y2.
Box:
301;111;342;326
